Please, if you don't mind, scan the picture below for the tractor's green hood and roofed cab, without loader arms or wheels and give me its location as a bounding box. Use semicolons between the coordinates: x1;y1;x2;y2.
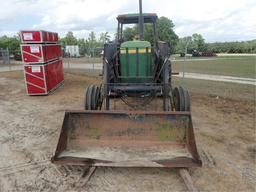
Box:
117;13;157;83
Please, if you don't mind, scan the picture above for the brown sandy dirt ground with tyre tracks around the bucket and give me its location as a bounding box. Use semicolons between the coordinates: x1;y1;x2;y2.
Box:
0;72;256;192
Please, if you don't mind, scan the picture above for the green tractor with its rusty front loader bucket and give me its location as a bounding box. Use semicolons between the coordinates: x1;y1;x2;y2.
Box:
52;1;202;177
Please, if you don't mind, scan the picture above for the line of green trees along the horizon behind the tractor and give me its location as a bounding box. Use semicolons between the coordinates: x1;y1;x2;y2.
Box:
0;17;256;55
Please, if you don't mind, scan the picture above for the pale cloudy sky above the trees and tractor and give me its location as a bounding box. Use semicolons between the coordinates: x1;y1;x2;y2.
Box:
0;0;256;42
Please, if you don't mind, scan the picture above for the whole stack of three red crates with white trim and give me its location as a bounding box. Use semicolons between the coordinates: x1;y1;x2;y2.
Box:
20;30;64;95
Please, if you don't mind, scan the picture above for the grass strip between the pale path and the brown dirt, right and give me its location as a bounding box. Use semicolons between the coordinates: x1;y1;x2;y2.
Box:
173;77;256;101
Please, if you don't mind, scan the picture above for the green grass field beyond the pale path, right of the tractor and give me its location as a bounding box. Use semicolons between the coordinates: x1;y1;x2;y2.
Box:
173;56;256;78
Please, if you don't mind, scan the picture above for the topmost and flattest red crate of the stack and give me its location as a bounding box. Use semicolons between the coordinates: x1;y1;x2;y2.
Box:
20;30;58;43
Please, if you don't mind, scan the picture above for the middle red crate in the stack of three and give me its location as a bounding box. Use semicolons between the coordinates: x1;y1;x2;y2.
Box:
21;44;61;64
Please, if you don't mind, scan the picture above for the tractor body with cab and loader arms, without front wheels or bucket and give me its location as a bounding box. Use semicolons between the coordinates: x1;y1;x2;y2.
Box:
103;11;171;110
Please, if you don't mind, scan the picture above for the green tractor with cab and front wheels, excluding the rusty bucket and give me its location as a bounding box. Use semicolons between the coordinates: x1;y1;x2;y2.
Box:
85;13;190;111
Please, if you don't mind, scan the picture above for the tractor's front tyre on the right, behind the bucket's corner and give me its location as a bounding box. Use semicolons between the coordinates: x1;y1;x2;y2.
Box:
172;86;190;111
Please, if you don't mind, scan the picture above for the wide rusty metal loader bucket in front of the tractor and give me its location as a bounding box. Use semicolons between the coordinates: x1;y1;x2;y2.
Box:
52;111;201;167
